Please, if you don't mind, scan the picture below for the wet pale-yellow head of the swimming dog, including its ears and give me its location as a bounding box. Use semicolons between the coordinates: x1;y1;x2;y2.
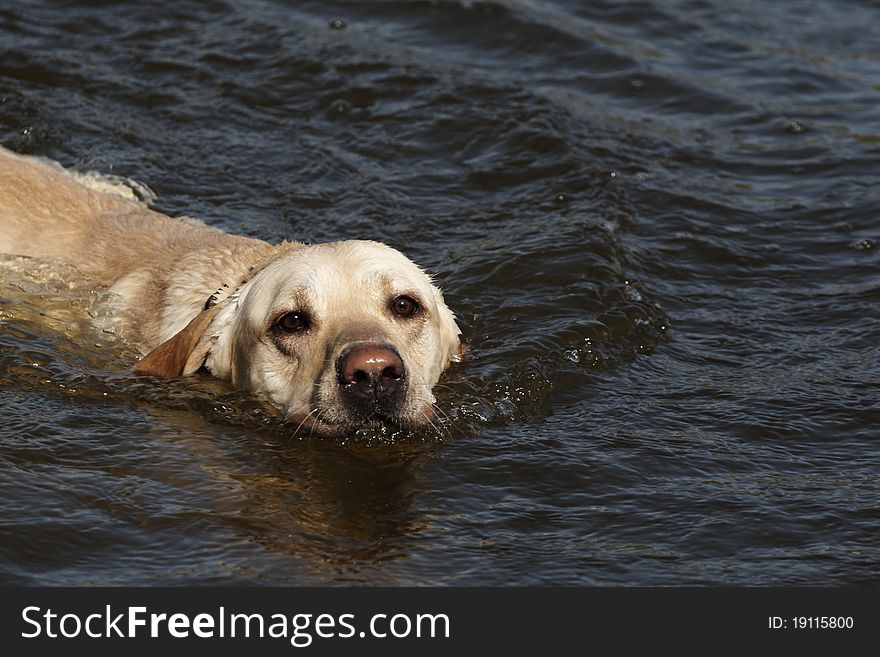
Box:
137;241;460;435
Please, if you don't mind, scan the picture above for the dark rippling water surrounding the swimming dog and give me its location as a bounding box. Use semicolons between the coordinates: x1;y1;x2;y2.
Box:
0;0;880;585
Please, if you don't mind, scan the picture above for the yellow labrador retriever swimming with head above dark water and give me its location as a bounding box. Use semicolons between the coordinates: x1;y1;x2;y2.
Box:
0;147;460;435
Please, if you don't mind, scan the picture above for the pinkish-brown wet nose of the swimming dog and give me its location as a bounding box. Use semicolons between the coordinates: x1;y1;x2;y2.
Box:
336;342;405;401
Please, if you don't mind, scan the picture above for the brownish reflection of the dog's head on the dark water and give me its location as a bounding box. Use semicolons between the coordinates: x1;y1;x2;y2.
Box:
145;413;438;573
